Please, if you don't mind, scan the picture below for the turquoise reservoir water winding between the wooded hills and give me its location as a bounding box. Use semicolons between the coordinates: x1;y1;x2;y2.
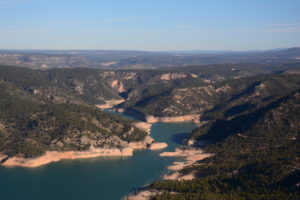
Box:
0;114;196;200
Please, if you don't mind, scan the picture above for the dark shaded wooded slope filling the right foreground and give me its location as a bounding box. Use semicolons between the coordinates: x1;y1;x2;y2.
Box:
150;92;300;200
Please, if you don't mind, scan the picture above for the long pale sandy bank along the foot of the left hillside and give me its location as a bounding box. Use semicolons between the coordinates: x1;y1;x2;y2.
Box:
2;148;133;167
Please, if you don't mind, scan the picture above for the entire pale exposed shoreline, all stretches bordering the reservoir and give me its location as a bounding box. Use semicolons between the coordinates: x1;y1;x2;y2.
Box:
0;100;205;200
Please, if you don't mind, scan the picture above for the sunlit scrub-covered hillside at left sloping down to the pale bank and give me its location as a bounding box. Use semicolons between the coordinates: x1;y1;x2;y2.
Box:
0;75;146;157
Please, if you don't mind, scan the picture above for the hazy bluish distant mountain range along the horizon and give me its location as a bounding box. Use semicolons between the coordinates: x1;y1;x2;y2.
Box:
0;47;300;69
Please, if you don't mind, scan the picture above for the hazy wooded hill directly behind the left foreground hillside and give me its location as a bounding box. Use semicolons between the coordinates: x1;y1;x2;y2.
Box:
0;66;120;106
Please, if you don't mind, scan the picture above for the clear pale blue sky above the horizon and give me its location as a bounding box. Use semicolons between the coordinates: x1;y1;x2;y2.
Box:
0;0;300;51
